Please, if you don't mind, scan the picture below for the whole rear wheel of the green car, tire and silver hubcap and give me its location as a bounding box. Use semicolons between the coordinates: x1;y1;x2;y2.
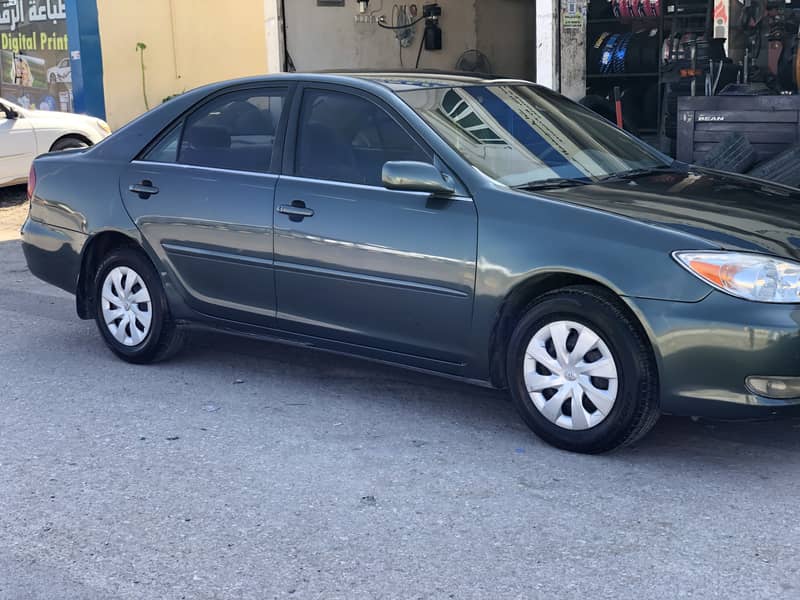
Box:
94;248;183;364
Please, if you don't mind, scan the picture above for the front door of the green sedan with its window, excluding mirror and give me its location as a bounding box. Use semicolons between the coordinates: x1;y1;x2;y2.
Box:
275;86;477;371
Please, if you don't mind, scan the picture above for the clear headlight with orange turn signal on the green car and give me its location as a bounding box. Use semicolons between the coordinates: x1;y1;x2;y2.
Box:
673;252;800;304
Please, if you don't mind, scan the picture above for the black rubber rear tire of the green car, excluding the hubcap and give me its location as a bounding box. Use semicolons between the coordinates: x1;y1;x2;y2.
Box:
94;247;184;364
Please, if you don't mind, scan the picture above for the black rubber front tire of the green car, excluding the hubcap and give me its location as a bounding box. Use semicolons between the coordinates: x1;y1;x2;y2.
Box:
507;293;649;452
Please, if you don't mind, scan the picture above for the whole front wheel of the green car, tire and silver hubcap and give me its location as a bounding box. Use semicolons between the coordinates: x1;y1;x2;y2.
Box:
507;286;660;454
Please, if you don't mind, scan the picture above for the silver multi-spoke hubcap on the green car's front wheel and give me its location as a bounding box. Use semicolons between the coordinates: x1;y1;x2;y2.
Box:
524;321;618;431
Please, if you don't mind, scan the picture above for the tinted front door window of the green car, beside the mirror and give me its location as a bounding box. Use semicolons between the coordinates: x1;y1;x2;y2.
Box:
295;90;431;186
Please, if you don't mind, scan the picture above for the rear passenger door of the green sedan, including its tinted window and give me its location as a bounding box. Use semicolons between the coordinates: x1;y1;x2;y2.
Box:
120;86;290;326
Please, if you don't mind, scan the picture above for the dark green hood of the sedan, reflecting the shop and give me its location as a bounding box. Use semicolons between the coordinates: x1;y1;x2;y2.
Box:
537;167;800;260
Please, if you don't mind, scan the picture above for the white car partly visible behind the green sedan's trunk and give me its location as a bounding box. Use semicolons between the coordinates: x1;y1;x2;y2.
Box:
0;98;111;187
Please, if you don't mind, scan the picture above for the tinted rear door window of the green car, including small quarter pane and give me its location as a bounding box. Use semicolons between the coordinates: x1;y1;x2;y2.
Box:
144;89;287;173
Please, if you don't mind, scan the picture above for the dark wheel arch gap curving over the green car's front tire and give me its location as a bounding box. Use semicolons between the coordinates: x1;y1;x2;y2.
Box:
489;270;661;389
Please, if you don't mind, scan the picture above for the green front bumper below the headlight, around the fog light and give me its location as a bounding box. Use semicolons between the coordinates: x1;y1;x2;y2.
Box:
627;291;800;419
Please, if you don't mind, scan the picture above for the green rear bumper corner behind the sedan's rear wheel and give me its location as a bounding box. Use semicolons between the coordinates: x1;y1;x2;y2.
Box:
22;218;88;294
